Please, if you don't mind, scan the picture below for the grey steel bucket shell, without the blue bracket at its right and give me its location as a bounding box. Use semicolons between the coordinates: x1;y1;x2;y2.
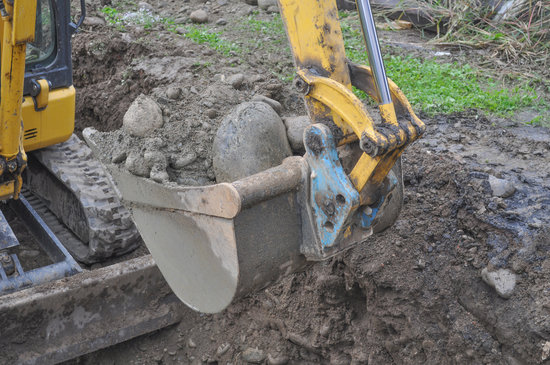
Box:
81;149;306;313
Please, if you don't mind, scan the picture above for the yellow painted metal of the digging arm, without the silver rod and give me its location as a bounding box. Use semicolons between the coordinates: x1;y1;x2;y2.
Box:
279;0;424;196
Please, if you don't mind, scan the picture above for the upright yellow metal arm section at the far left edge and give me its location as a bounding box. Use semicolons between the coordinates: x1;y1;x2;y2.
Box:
0;0;36;200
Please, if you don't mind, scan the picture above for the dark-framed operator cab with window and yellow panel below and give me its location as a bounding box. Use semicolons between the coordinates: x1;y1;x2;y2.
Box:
22;0;84;152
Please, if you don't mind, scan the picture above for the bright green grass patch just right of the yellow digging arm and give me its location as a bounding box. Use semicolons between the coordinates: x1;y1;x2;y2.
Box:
341;14;548;120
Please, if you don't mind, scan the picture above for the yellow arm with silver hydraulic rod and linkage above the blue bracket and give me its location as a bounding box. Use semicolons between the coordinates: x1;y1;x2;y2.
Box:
279;0;425;199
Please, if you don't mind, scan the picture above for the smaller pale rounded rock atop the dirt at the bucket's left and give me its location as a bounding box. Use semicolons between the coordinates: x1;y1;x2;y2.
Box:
122;94;164;137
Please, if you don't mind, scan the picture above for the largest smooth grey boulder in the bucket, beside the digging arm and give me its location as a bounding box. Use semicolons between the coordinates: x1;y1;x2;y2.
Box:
212;102;292;182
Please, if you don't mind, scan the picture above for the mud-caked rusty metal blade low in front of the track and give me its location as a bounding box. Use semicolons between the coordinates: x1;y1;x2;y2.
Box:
0;255;191;364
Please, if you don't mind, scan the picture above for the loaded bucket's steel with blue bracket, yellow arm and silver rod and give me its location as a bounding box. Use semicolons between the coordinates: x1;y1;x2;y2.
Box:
83;0;425;313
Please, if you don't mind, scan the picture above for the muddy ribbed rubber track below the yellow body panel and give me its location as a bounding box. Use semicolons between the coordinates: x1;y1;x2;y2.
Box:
30;135;141;264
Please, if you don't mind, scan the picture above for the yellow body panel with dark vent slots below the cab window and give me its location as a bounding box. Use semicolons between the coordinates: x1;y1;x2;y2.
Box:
22;86;75;151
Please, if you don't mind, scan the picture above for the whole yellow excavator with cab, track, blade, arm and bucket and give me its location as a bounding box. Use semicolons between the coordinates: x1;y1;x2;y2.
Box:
0;0;425;364
